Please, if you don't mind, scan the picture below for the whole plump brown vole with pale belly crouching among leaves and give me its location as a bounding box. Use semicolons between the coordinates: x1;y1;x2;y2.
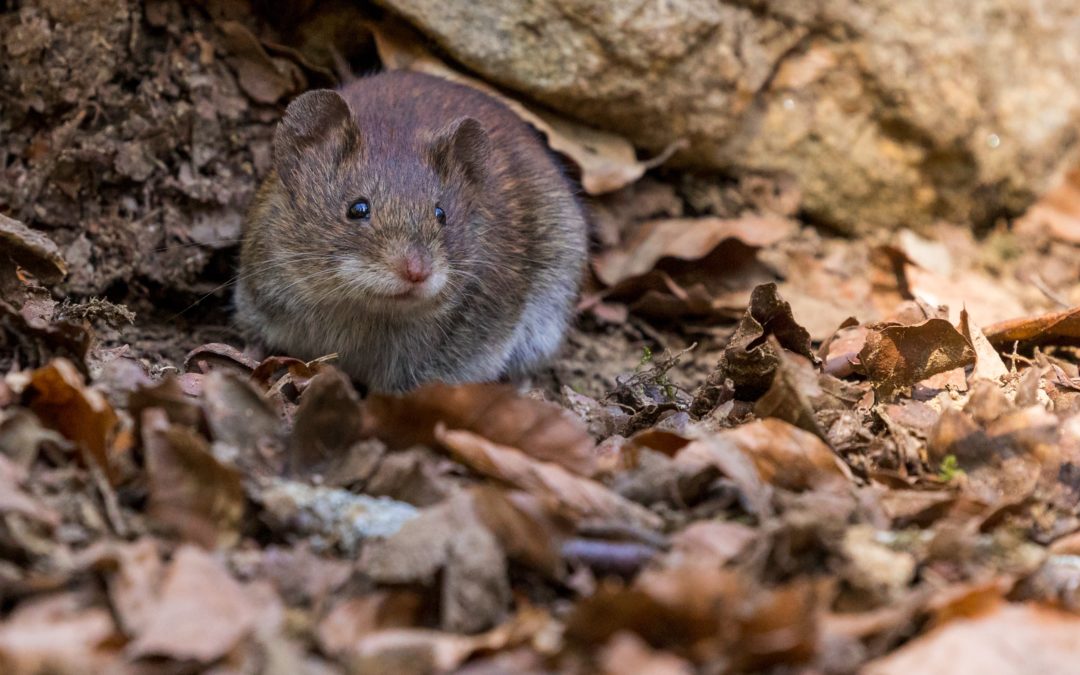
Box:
234;71;586;392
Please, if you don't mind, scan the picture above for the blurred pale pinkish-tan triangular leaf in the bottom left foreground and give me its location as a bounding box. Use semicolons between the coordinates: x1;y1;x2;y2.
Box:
127;545;259;664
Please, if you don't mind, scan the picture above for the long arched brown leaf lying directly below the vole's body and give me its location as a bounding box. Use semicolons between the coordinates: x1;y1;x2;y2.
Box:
364;383;595;475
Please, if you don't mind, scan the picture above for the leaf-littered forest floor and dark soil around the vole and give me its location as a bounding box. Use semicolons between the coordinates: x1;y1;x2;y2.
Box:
6;1;1080;675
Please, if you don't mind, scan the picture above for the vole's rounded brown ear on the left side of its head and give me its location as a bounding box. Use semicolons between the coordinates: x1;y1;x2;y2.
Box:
273;89;360;178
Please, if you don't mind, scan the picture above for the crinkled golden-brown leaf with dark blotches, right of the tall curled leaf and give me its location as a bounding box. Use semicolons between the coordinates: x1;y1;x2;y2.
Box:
859;319;975;401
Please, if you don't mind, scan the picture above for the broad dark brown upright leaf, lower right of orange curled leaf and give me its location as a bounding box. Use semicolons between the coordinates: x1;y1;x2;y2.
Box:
143;409;246;549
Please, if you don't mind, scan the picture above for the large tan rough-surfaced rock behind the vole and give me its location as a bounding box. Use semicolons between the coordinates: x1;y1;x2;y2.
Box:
379;0;1080;231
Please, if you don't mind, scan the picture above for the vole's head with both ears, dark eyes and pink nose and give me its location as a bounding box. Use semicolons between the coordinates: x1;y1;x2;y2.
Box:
264;90;490;312
